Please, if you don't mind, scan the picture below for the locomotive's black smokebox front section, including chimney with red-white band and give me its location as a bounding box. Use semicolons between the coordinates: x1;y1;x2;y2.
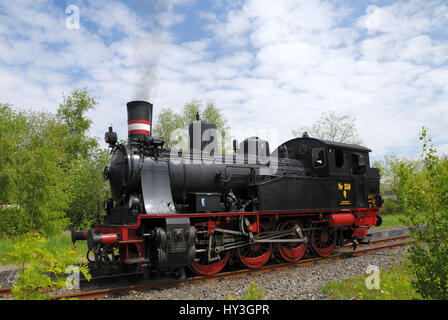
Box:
104;101;175;218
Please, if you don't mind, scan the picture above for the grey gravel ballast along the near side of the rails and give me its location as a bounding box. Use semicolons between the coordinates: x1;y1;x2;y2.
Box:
105;247;407;300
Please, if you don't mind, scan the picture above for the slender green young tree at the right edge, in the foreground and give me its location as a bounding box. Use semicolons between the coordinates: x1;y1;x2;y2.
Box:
404;128;448;299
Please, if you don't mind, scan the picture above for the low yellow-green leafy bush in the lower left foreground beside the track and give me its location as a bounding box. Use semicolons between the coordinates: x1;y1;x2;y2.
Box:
1;233;91;300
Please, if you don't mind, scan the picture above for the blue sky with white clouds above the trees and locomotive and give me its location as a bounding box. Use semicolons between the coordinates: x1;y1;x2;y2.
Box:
0;0;448;158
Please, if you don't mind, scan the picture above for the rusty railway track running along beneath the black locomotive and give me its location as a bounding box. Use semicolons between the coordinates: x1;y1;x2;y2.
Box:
0;235;414;300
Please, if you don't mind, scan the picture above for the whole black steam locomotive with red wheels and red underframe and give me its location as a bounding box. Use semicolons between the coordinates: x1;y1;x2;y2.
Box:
72;101;383;275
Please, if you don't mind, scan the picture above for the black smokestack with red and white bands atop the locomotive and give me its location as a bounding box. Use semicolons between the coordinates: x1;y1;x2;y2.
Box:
126;101;152;141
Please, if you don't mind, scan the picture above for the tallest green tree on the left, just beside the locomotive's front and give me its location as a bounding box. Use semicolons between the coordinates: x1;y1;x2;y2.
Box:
57;88;109;228
